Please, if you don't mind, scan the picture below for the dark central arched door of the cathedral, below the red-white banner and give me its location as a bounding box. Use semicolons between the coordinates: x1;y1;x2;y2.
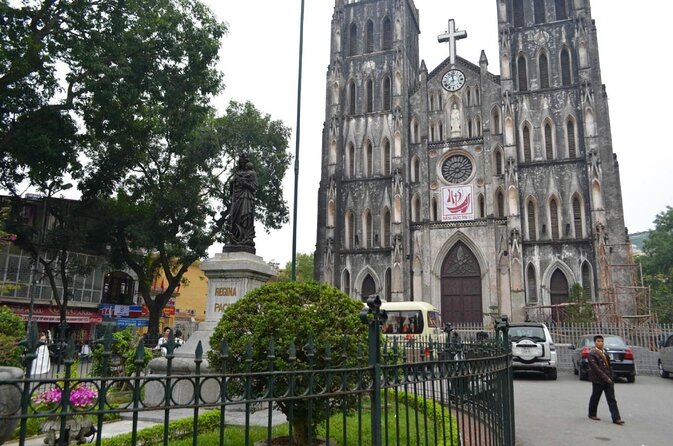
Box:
441;242;484;323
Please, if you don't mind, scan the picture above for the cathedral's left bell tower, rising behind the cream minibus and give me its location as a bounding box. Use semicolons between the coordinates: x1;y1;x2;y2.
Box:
315;0;420;299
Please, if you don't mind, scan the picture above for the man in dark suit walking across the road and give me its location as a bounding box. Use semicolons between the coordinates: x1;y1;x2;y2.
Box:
589;335;624;426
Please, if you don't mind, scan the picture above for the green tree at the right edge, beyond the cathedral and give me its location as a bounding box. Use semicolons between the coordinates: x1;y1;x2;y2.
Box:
638;206;673;323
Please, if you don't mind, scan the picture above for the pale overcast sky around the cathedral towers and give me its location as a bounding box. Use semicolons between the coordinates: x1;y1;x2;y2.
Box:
204;0;673;267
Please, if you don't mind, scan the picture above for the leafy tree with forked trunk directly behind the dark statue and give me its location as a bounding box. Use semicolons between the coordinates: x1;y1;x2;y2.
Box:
88;102;291;339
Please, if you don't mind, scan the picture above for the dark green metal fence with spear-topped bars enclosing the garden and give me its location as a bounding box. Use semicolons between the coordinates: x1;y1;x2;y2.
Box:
0;299;514;446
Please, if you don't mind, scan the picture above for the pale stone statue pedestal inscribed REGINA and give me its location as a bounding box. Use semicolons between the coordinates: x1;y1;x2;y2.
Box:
144;252;276;405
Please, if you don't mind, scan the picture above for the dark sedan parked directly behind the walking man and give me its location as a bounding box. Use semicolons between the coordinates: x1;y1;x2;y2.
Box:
570;334;636;383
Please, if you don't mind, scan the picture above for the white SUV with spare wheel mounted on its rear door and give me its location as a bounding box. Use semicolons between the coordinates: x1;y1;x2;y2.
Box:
509;322;557;380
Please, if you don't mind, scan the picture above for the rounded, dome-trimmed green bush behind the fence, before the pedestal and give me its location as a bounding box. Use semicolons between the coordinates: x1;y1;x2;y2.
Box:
208;282;367;446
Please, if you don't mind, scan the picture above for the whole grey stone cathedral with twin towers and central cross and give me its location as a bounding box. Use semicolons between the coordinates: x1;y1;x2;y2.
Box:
315;0;636;323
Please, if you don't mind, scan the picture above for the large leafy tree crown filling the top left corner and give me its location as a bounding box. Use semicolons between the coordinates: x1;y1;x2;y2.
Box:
0;0;226;196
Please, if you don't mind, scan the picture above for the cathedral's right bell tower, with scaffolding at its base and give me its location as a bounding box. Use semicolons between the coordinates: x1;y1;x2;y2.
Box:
496;0;636;320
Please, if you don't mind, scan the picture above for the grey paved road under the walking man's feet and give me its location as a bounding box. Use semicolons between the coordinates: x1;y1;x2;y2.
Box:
514;373;673;446
